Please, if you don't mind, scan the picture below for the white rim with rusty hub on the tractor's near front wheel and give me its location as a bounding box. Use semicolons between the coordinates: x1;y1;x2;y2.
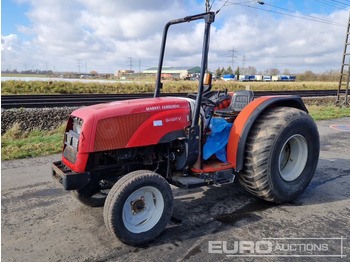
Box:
122;186;164;233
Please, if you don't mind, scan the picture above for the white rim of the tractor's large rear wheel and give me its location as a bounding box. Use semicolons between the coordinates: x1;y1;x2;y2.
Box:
278;134;308;182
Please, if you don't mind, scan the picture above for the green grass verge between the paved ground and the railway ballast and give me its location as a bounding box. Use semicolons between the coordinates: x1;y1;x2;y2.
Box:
1;105;350;160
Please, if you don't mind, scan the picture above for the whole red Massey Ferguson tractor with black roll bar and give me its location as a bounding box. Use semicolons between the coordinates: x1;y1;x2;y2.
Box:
52;12;319;245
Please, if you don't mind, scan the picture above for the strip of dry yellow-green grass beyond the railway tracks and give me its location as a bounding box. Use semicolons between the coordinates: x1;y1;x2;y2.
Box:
1;81;338;95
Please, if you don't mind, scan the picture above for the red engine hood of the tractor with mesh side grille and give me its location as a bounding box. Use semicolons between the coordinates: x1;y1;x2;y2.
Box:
72;97;193;153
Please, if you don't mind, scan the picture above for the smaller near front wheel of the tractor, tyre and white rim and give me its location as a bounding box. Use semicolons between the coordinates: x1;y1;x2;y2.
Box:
103;170;173;246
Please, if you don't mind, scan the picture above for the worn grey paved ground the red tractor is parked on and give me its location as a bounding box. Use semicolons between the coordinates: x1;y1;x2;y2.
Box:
1;117;350;262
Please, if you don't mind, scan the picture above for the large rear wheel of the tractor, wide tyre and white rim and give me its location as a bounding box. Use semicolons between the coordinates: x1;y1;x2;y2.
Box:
239;107;320;203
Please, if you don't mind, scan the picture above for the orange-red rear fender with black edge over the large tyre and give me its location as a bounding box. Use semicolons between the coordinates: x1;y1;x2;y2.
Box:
227;96;308;172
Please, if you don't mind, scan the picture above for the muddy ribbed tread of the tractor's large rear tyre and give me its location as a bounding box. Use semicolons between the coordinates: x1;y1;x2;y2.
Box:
238;107;320;203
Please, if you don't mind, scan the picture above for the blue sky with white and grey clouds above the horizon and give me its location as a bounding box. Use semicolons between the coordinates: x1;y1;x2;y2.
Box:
1;0;350;74
